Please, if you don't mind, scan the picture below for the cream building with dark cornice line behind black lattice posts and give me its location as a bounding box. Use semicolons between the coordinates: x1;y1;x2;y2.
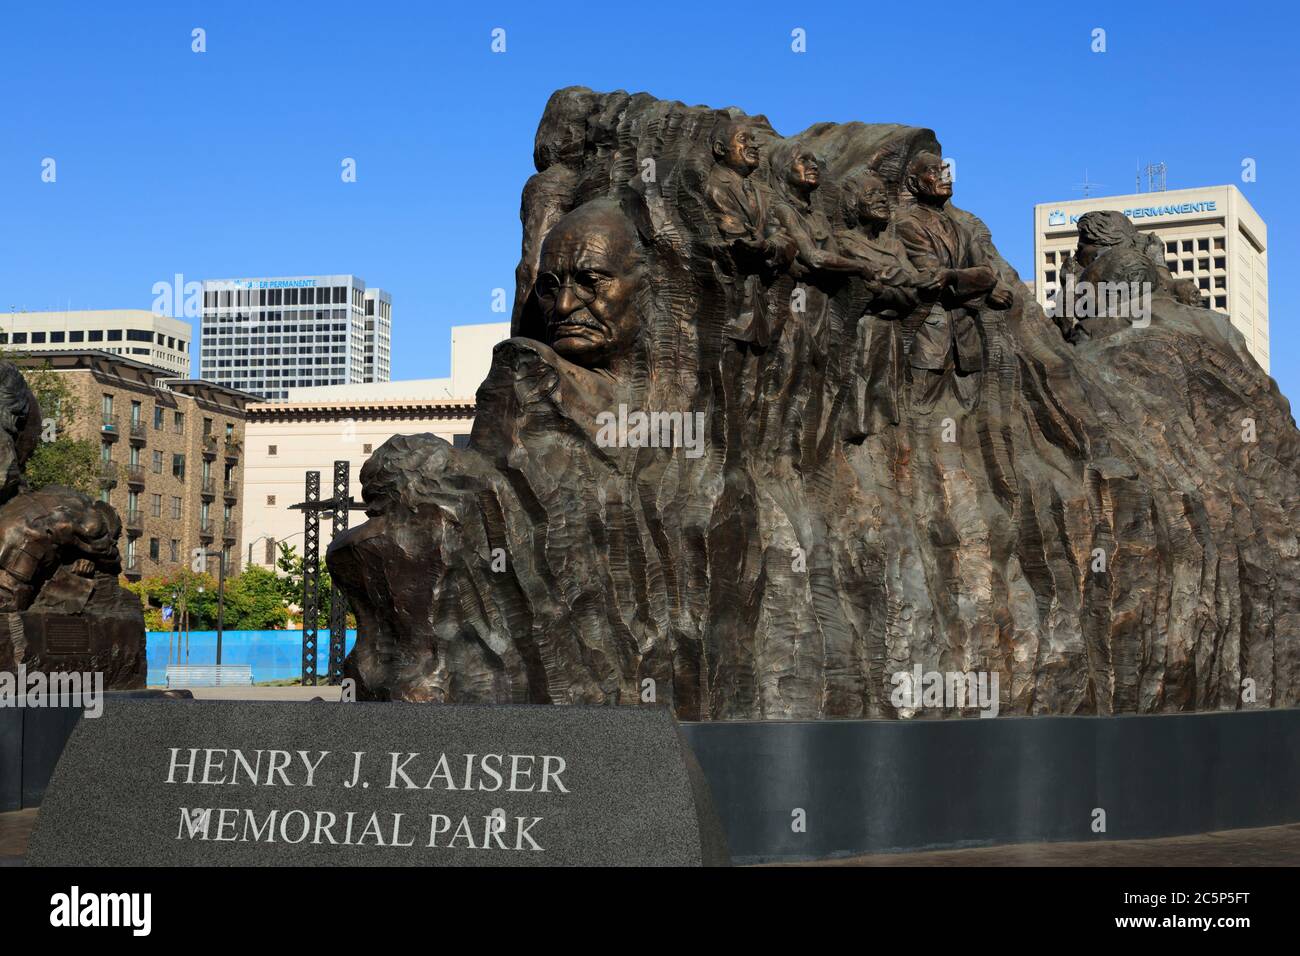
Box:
243;323;510;567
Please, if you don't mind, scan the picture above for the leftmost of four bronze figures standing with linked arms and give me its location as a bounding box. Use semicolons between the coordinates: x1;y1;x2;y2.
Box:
705;120;794;347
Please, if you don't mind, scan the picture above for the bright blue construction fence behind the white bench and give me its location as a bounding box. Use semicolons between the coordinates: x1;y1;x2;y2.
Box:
147;628;356;687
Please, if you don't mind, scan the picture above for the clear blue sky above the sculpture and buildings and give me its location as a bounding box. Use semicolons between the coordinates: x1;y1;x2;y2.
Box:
0;0;1300;395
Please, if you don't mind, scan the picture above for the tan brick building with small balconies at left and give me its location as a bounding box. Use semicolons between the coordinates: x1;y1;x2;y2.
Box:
13;350;255;580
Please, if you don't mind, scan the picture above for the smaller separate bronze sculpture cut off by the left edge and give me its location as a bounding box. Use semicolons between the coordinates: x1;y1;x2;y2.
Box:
0;362;147;689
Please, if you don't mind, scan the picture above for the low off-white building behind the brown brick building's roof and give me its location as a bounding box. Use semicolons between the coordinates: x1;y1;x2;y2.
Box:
0;308;192;378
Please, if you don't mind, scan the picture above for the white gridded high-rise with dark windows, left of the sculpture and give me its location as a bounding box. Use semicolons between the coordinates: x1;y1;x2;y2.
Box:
199;276;393;399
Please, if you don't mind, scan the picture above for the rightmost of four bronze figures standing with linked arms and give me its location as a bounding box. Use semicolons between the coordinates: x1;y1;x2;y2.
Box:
894;152;1014;412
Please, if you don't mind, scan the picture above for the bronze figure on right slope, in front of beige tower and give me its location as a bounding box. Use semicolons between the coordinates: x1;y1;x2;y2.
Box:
1052;209;1201;343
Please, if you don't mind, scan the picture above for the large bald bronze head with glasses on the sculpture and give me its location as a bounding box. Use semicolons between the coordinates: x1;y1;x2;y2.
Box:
536;199;645;368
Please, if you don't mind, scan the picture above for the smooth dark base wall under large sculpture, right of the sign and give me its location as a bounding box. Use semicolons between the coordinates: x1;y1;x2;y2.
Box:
681;709;1300;864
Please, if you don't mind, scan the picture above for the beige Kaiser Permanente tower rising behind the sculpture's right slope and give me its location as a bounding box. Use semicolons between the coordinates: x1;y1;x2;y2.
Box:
1034;185;1269;372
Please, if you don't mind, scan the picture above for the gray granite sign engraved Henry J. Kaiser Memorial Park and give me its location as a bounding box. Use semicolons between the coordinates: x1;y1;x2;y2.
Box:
27;701;727;866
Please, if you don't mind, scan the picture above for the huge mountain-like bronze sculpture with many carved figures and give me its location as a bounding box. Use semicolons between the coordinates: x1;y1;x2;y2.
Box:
329;88;1300;719
